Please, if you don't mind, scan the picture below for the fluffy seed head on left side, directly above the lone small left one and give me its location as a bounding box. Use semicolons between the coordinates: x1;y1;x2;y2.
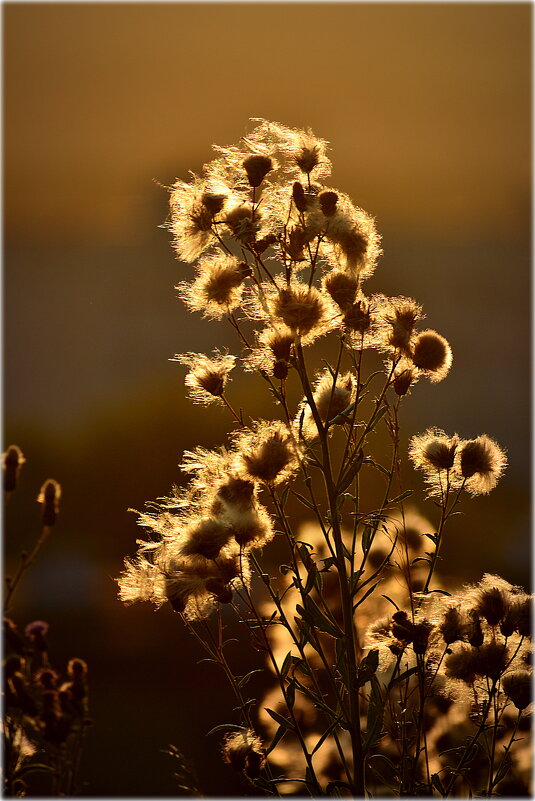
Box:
177;253;251;319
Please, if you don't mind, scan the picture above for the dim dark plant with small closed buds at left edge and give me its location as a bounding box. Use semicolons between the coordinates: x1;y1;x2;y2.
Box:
2;445;91;797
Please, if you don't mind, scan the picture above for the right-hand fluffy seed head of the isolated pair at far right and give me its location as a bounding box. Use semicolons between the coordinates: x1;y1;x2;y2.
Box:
459;434;507;495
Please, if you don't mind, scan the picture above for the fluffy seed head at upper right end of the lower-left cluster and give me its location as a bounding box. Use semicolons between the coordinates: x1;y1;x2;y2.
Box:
235;421;299;486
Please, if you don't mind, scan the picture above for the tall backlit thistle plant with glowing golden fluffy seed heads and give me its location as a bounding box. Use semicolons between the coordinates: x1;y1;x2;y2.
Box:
118;120;532;798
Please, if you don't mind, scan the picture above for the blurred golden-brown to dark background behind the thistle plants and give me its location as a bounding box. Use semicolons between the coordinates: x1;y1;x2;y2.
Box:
3;3;531;796
